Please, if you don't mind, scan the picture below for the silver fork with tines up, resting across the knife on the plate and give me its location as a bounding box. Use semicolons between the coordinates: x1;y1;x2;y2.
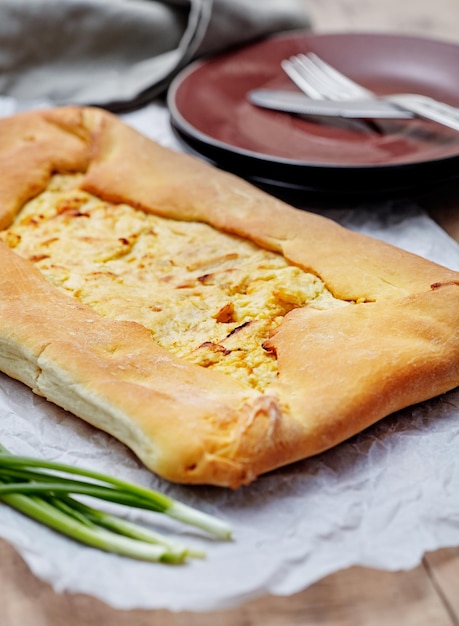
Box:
281;52;459;131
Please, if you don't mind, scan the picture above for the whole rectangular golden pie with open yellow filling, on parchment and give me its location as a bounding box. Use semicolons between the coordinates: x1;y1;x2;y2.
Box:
0;107;459;488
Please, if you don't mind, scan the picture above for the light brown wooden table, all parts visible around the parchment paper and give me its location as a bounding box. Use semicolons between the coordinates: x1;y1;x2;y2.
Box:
0;0;459;626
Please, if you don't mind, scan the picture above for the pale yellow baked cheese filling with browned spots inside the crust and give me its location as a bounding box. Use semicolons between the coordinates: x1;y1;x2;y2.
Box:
0;175;345;391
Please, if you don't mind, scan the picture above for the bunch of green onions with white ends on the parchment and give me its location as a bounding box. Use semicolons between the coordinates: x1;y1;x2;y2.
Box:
0;445;231;563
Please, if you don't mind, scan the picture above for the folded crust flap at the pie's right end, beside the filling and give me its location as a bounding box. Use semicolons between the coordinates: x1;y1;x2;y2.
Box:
270;284;459;456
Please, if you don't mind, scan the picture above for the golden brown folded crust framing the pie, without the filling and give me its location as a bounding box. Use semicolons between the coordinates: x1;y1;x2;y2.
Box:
0;108;459;487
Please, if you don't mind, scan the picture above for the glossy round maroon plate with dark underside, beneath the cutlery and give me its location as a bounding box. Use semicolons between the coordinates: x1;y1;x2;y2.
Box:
168;32;459;191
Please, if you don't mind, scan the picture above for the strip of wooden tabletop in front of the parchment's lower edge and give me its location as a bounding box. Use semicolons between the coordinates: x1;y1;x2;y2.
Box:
0;541;459;626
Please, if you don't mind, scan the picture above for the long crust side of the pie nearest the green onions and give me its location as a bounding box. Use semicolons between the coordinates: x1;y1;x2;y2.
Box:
0;243;300;486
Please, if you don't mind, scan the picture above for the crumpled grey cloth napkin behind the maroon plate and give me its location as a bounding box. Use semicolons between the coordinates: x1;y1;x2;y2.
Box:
0;0;309;110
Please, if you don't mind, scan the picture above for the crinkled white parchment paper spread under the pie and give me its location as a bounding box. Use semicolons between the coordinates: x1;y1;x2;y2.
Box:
0;104;459;611
